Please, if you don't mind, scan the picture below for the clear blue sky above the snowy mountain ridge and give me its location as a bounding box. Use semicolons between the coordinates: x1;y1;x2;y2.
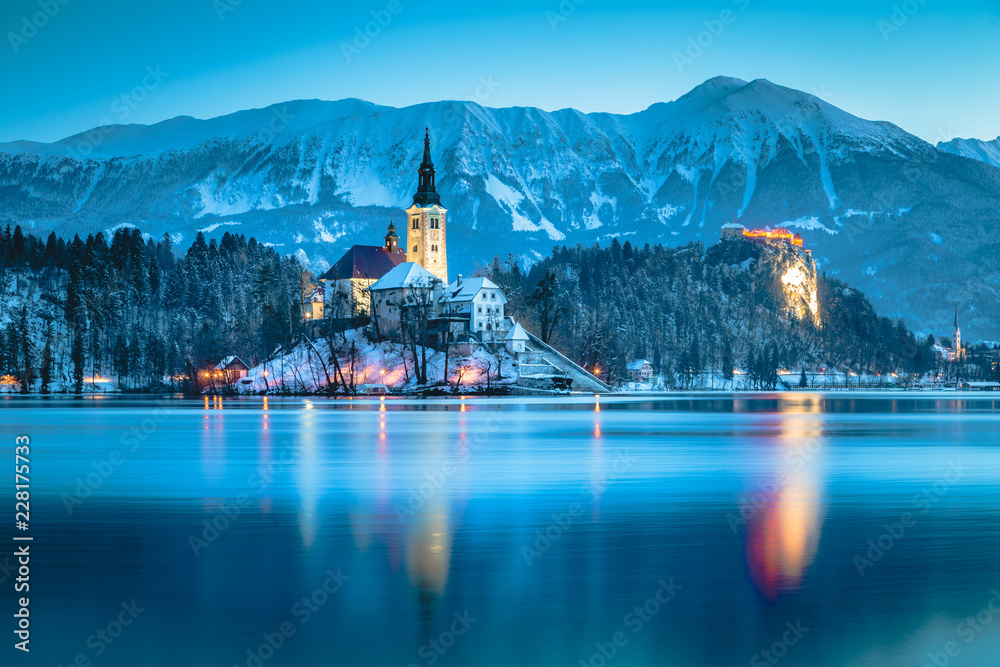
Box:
0;0;1000;142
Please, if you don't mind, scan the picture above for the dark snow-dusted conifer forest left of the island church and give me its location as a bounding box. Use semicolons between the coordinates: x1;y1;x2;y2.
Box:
0;227;303;392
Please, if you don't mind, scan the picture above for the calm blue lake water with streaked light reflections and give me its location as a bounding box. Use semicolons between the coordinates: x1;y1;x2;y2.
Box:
0;393;1000;667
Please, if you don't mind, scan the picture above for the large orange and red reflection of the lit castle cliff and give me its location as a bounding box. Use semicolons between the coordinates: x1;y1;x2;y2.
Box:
737;396;825;599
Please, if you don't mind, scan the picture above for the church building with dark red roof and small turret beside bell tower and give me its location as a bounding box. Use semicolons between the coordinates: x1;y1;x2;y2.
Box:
320;221;406;317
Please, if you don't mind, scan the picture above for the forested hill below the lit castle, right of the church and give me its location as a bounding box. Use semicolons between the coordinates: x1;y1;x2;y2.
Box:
488;239;988;388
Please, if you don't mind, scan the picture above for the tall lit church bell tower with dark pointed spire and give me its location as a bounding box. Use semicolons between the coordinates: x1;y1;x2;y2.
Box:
406;128;448;283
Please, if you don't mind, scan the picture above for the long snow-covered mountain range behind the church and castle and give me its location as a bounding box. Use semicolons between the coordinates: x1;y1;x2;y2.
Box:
0;77;1000;338
